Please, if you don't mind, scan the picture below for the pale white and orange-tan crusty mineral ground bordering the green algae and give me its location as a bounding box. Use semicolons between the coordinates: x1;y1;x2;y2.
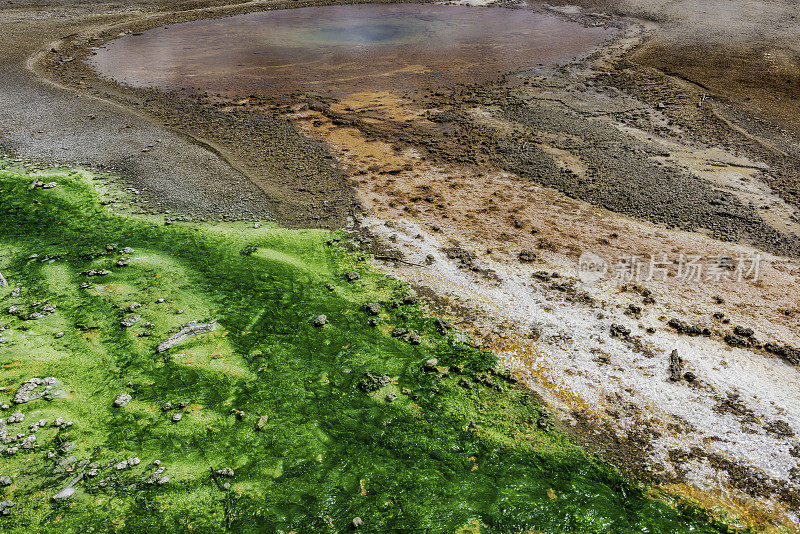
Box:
289;47;800;530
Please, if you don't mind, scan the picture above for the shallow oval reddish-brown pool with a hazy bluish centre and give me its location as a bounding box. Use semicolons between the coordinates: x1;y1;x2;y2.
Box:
89;4;610;96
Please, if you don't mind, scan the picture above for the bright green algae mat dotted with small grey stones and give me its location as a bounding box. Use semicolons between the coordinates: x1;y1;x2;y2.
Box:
0;160;728;533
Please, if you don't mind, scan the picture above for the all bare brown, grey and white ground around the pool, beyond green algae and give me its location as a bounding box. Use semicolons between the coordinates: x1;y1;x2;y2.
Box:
0;0;800;531
